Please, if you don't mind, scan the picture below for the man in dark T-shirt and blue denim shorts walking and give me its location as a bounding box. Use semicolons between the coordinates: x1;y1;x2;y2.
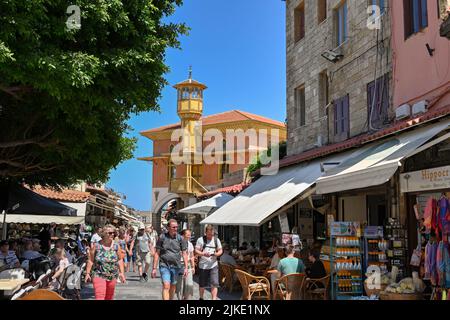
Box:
152;219;188;300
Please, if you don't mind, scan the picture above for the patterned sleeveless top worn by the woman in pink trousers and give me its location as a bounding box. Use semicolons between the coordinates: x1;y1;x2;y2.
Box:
93;243;119;281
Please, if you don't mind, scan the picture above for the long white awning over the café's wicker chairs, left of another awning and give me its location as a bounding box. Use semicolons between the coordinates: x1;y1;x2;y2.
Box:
200;153;348;226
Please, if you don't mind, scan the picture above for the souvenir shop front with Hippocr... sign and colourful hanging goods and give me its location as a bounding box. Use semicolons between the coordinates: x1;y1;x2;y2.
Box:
400;139;450;300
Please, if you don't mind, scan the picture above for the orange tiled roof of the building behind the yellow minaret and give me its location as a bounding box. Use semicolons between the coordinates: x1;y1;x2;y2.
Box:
141;110;286;134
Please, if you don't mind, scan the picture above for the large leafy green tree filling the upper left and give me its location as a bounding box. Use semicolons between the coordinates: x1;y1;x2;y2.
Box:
0;0;187;187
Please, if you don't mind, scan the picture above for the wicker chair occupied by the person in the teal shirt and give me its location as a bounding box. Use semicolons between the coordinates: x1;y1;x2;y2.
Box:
273;273;306;300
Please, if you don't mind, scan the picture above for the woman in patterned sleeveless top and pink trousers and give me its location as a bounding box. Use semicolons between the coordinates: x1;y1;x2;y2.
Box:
85;225;126;300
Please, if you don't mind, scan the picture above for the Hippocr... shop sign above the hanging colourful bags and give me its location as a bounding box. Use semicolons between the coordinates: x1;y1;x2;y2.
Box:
400;166;450;192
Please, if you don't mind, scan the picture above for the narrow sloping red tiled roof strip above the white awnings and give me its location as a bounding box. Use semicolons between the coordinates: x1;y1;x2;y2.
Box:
280;106;450;167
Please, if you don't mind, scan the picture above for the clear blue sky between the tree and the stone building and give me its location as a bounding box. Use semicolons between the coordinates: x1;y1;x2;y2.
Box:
107;0;286;210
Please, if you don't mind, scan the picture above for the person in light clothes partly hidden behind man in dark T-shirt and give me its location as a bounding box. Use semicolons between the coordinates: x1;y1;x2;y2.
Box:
176;229;195;300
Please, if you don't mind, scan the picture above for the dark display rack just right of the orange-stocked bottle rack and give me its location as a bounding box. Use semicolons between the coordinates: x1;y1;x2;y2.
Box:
364;226;389;274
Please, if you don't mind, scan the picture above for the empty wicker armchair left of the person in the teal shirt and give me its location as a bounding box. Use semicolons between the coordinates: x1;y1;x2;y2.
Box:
234;269;270;300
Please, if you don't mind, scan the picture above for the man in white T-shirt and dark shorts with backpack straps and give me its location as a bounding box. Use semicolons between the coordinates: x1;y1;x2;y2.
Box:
195;225;223;300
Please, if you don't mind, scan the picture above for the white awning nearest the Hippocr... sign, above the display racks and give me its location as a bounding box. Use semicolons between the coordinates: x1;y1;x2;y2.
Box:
316;119;450;194
